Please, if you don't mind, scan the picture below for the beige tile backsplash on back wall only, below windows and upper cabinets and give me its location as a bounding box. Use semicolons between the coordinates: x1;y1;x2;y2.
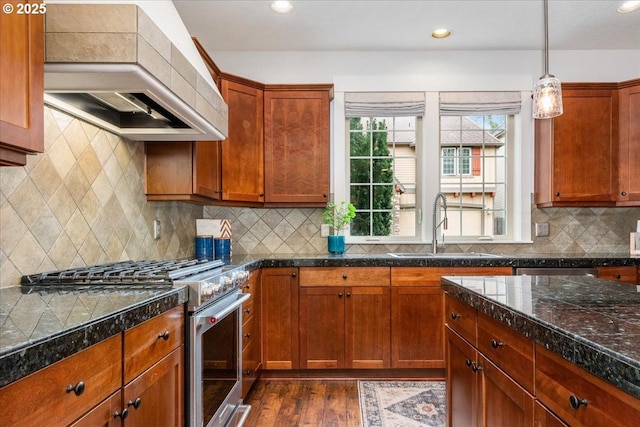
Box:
204;206;640;255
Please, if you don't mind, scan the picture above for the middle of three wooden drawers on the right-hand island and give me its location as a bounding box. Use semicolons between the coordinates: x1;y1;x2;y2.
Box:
477;313;534;393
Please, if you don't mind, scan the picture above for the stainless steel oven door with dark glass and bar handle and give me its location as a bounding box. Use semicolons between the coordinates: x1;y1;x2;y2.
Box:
187;291;250;427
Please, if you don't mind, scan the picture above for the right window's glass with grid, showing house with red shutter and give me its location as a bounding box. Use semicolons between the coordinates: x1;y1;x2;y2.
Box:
440;114;510;238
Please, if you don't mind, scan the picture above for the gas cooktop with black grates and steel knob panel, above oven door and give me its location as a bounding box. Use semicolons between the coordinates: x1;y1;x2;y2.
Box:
20;259;249;312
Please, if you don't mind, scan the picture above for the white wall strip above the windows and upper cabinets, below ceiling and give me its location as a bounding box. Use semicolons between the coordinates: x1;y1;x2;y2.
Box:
209;50;640;85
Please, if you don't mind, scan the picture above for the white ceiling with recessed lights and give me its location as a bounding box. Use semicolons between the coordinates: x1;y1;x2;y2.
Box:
174;0;640;52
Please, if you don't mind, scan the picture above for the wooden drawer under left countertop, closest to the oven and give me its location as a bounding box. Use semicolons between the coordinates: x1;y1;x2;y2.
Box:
124;306;185;384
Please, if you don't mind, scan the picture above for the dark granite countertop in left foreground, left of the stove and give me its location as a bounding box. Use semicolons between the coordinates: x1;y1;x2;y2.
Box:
0;286;188;387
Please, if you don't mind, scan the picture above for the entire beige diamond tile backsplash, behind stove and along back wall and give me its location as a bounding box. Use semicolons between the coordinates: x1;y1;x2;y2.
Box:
0;108;640;287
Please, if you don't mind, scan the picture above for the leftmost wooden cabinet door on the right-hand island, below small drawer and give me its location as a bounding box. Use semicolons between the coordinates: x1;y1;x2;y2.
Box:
445;327;478;427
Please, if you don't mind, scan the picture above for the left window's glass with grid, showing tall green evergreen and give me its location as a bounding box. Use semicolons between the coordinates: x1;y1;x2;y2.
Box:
349;116;419;237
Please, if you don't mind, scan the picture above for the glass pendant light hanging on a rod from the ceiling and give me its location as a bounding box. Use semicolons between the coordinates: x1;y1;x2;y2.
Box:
533;0;562;119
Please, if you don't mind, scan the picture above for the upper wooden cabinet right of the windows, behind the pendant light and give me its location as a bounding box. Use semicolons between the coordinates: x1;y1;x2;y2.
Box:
534;80;640;207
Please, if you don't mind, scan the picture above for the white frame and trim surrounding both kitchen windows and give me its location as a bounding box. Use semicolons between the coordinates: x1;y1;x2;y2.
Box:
331;85;534;245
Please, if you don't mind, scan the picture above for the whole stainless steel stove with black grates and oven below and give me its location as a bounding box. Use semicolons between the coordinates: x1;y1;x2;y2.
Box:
21;260;250;427
